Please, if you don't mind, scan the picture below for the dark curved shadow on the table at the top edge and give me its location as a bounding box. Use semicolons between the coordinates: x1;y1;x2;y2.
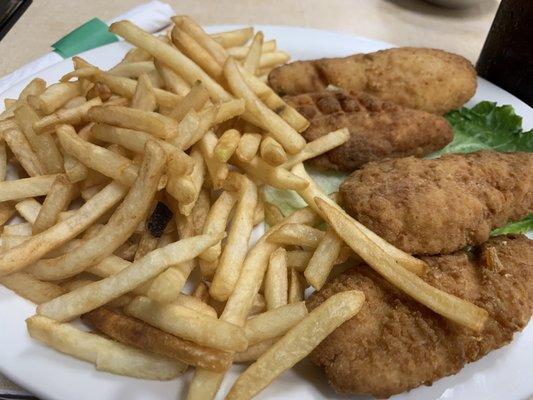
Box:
385;0;499;18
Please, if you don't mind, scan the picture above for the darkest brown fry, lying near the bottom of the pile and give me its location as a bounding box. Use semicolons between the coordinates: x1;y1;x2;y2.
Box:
82;307;231;372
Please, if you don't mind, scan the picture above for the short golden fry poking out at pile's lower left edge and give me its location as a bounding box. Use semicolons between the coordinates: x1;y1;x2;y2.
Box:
0;272;64;304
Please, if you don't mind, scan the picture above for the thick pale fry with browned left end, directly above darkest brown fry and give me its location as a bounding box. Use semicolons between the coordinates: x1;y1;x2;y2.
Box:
124;297;248;351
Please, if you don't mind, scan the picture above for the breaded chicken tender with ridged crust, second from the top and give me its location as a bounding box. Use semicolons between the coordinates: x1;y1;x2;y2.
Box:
284;90;453;172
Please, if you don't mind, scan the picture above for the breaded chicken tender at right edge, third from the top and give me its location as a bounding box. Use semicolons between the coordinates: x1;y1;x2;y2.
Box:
340;151;533;254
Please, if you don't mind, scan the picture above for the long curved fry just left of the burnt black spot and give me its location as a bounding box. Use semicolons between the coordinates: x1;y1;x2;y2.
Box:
30;142;164;280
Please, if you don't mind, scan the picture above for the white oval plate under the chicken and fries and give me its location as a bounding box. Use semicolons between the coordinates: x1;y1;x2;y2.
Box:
0;26;533;400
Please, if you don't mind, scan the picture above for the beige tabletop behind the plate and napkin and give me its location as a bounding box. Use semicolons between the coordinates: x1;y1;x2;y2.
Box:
0;0;499;393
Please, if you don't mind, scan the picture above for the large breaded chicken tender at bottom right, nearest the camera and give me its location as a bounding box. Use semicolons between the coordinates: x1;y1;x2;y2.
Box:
308;236;533;398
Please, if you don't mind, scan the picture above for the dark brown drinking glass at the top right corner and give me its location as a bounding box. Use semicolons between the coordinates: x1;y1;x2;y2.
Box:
476;0;533;107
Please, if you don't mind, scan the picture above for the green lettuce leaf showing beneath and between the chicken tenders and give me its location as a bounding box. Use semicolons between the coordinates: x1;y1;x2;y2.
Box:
265;101;533;235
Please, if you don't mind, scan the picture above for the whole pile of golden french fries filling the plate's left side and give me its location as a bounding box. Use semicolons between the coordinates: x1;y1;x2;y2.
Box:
0;16;487;400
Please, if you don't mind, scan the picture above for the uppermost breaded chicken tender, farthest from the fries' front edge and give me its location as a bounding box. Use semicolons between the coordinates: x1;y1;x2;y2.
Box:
268;47;477;114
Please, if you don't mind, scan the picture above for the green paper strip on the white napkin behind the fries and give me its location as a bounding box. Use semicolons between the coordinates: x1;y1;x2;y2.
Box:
52;18;118;58
